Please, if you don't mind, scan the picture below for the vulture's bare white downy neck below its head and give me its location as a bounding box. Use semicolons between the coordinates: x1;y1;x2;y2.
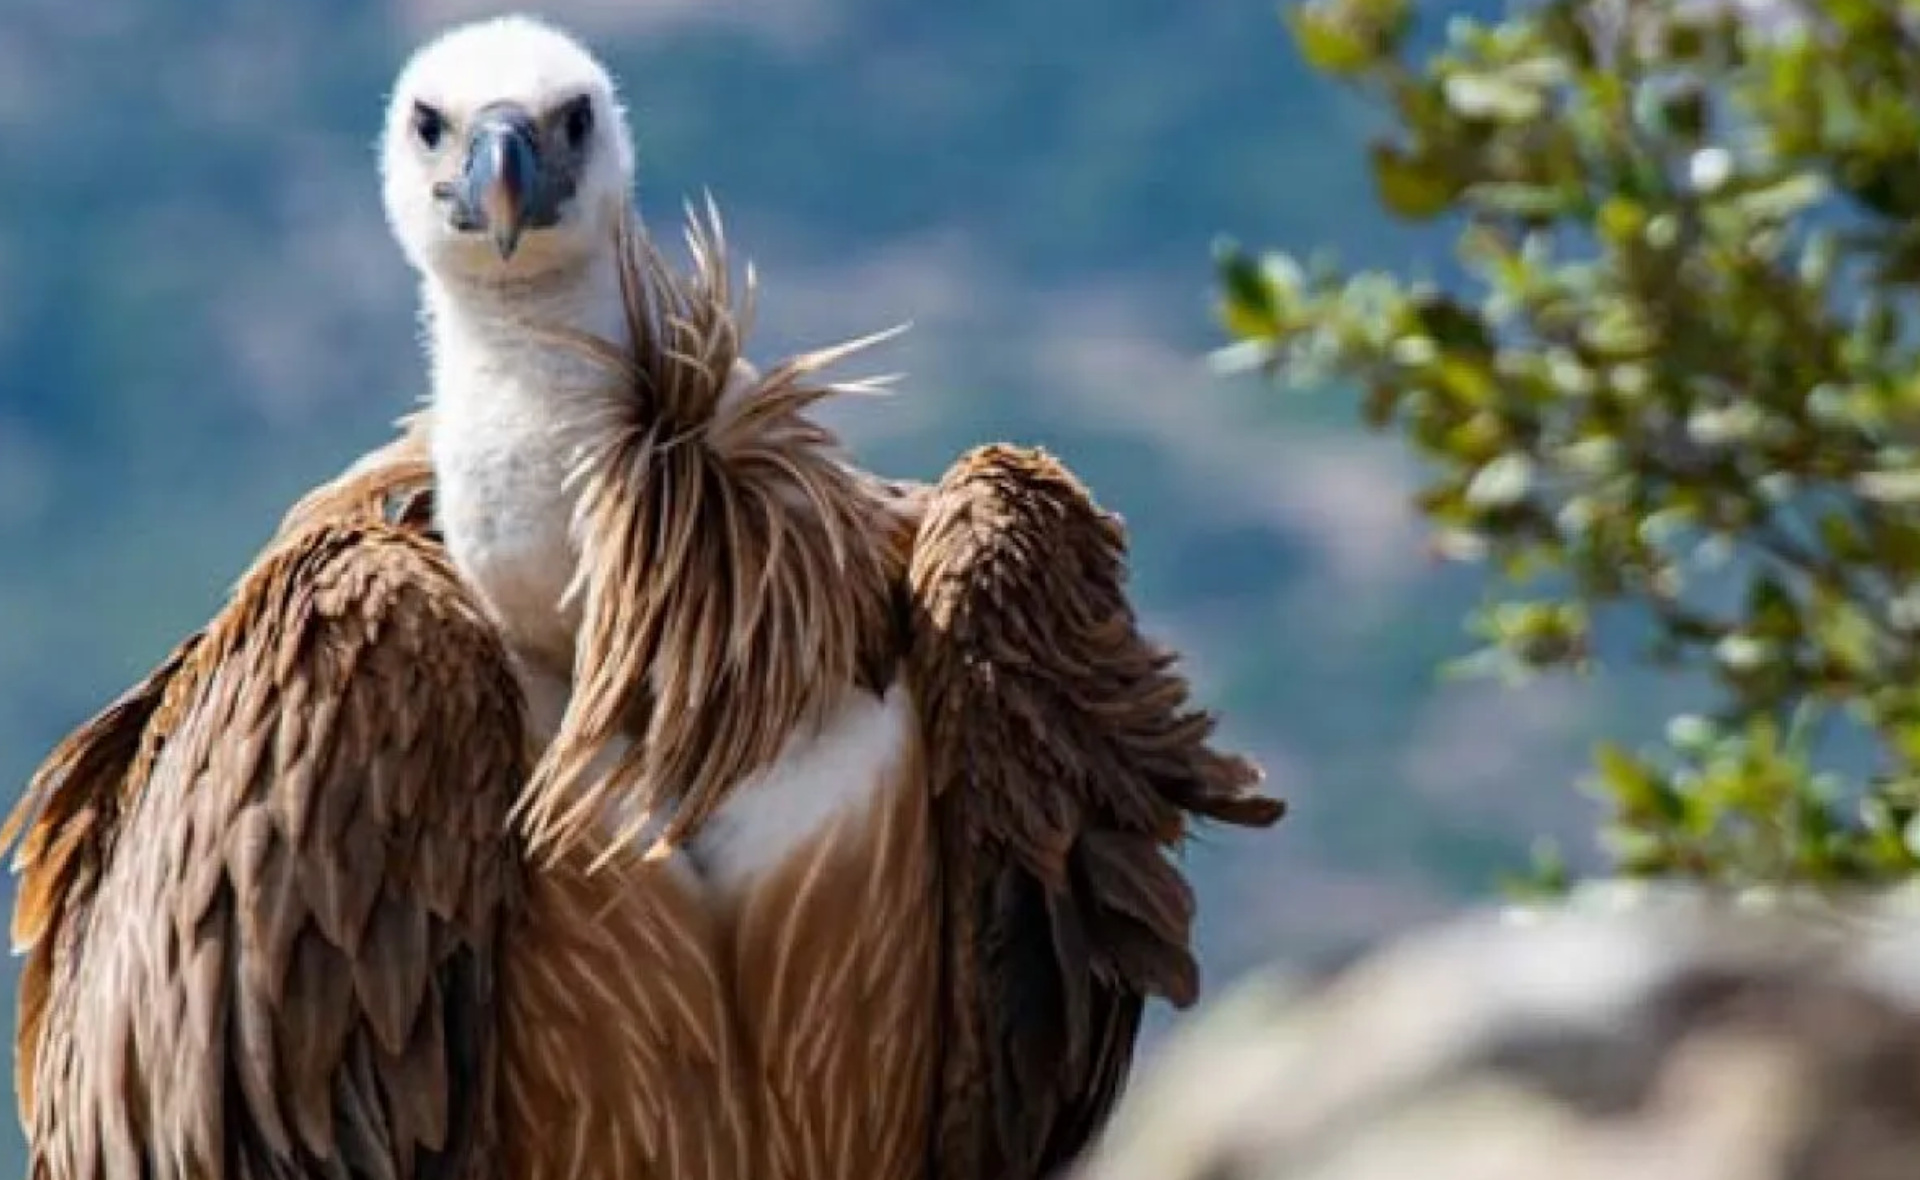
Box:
422;255;628;672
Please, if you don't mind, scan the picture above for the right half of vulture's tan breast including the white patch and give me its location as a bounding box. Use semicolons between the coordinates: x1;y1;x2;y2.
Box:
689;683;939;1180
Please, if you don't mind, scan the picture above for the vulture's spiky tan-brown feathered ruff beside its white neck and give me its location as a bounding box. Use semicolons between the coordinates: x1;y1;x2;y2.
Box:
520;201;900;856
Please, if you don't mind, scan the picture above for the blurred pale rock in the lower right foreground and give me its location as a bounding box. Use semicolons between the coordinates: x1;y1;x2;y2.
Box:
1075;888;1920;1180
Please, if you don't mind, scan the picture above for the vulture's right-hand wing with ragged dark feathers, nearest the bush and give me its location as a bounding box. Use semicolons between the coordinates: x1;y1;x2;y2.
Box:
908;447;1283;1180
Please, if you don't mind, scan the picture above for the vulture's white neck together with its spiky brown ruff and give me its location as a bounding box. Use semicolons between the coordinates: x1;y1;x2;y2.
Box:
414;209;904;854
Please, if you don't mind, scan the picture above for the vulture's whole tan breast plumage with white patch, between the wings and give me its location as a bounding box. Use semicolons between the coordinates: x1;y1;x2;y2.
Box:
501;683;939;1180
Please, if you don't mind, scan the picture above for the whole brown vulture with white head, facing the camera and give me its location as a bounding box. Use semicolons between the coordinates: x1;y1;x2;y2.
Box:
6;17;1283;1180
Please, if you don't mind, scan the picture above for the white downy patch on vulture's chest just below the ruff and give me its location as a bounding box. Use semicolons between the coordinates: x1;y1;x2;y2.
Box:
689;681;914;892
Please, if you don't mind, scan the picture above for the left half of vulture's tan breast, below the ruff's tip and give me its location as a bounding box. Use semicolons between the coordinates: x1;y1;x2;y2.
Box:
499;846;768;1180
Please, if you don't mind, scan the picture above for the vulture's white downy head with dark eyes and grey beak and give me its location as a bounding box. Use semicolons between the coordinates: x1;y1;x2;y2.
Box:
380;15;634;284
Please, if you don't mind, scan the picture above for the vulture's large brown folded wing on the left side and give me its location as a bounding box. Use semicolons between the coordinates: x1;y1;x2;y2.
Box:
10;464;524;1180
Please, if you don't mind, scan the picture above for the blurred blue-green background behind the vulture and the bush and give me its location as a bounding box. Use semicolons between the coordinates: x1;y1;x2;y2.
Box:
0;0;1681;1157
